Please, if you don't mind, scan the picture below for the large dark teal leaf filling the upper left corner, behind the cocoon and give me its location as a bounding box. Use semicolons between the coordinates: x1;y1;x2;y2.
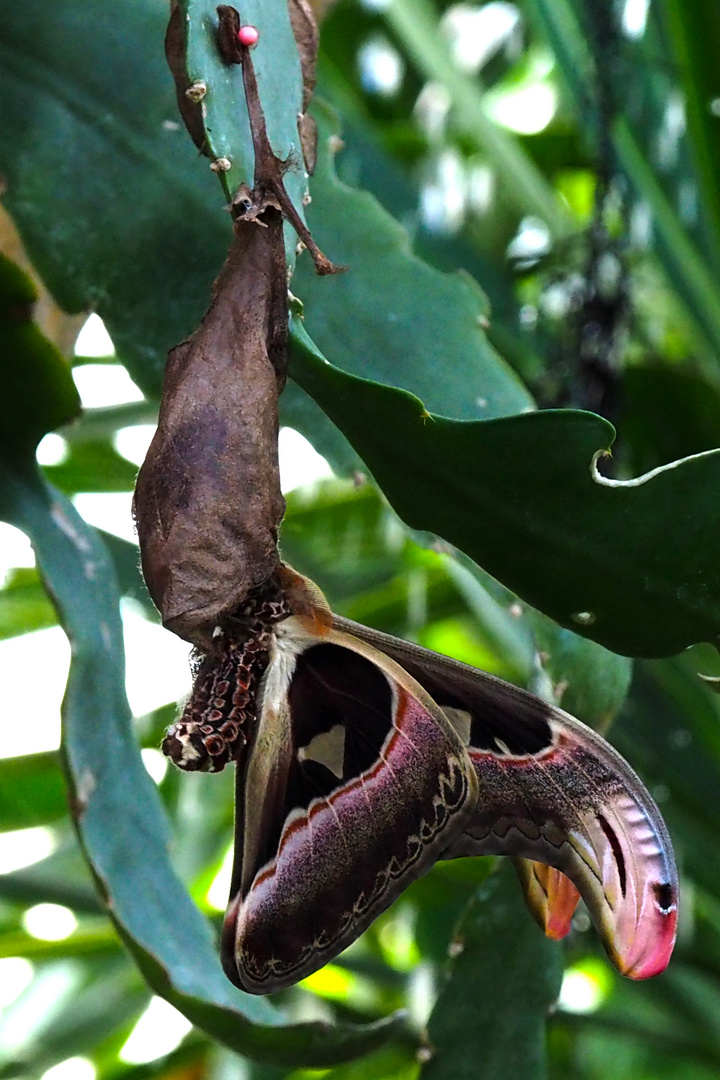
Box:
0;0;231;396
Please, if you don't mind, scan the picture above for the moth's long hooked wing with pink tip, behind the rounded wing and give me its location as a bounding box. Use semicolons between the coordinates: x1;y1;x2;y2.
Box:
335;617;678;978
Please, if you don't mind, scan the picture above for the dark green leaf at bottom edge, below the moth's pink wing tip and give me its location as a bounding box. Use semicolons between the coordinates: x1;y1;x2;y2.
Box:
421;861;562;1080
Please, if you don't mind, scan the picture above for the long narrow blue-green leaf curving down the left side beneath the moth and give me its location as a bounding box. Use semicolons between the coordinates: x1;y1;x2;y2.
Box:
0;460;397;1065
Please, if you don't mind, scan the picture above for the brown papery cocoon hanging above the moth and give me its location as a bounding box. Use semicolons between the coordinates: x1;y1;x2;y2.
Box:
135;204;287;648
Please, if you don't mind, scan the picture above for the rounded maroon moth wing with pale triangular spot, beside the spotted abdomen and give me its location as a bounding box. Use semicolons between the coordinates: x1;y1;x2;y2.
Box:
223;618;477;994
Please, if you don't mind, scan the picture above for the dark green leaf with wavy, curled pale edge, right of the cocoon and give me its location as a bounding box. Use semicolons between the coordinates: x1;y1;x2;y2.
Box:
293;324;720;657
